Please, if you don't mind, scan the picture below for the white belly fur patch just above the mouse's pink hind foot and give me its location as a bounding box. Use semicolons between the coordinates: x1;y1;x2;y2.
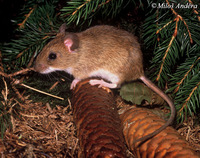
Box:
89;69;119;84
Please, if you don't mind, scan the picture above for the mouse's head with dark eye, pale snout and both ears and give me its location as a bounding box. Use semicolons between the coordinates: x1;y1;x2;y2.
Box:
34;25;79;74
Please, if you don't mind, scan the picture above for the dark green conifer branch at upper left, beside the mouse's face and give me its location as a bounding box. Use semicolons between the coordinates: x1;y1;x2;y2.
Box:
2;1;59;69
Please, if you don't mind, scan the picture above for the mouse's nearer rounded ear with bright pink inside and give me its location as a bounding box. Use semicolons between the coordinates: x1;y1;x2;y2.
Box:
64;33;79;53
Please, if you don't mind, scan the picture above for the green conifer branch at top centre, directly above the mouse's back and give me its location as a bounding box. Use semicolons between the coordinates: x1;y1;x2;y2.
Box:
61;0;126;25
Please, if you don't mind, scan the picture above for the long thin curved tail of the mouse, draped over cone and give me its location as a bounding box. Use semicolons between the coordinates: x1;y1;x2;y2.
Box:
134;76;176;144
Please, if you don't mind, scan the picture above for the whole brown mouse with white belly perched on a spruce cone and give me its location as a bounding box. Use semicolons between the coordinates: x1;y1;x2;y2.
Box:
34;25;175;142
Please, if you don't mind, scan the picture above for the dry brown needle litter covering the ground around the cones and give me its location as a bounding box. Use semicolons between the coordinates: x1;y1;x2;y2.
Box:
0;93;200;158
